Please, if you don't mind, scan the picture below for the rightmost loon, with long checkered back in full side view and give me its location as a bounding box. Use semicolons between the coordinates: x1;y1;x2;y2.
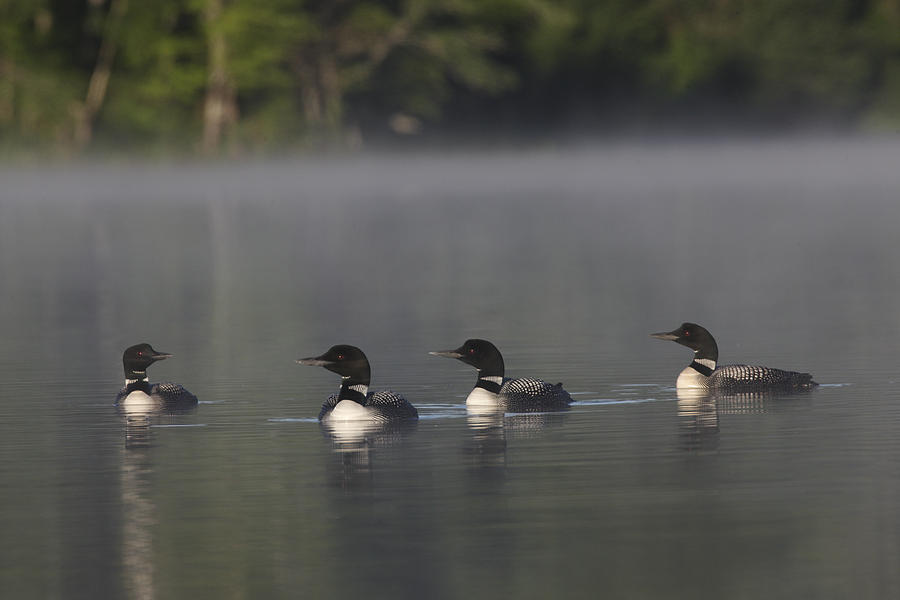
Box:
650;323;819;392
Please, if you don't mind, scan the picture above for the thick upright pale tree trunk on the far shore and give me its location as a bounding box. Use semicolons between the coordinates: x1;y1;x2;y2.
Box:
203;0;238;154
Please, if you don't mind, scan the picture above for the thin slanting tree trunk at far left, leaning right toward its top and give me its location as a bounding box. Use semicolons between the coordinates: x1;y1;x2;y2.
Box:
75;0;128;150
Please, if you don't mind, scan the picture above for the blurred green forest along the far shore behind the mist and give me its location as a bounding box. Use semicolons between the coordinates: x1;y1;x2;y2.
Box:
0;0;900;158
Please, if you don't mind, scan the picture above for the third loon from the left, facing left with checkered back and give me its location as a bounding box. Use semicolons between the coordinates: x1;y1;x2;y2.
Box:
429;339;572;412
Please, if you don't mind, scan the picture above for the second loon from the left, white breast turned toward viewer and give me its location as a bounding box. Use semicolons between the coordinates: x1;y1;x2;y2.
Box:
297;344;419;422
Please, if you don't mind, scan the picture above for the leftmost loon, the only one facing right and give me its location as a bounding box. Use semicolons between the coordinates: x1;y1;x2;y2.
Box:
116;344;197;408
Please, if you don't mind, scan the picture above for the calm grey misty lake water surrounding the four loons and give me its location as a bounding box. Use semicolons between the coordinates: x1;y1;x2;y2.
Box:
0;140;900;599
